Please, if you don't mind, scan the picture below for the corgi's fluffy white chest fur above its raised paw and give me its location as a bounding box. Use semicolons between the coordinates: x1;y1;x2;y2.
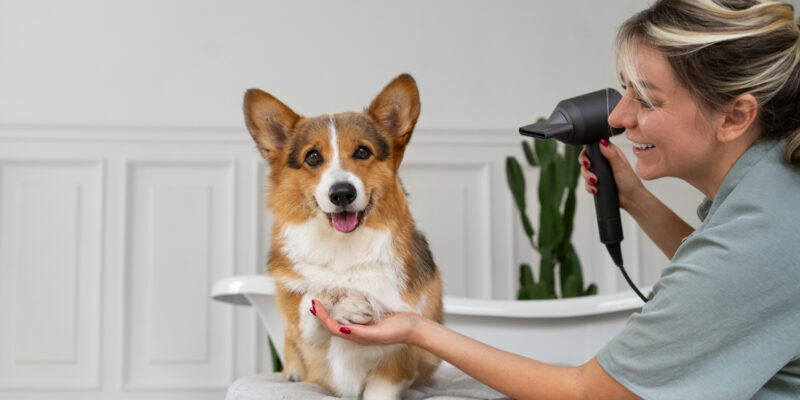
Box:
280;215;415;312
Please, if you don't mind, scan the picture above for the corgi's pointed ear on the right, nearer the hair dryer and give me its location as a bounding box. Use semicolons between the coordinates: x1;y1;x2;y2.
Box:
367;74;420;145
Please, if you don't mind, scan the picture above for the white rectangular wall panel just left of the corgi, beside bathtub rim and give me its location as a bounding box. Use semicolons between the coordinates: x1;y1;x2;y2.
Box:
124;161;235;388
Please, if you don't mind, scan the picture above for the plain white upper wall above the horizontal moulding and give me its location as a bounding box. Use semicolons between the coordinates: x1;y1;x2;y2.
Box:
0;0;645;128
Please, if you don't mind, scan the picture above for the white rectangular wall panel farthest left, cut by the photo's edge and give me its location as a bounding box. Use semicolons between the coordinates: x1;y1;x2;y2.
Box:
0;159;103;388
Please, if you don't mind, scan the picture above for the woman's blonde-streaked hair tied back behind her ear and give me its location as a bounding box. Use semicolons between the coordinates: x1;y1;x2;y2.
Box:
616;0;800;162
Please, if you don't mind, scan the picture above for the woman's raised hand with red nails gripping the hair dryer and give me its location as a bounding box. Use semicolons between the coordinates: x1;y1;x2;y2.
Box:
578;139;646;211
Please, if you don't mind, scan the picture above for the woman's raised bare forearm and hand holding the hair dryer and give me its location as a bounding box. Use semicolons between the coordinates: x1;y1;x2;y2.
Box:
578;143;694;259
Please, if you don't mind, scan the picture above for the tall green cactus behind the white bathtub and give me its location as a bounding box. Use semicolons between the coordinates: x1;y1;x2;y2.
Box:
506;136;597;300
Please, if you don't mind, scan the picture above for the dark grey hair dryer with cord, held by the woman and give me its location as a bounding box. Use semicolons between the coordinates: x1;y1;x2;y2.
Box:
519;89;647;301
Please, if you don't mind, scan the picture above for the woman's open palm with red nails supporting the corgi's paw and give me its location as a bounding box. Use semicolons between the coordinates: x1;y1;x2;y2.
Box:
311;300;422;346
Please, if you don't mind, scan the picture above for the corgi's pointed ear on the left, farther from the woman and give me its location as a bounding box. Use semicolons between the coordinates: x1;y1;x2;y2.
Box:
243;89;300;158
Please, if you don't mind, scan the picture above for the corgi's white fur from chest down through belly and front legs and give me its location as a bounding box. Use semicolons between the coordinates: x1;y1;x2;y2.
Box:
280;216;412;398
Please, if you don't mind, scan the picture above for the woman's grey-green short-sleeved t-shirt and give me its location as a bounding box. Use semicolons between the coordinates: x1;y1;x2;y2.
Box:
597;141;800;400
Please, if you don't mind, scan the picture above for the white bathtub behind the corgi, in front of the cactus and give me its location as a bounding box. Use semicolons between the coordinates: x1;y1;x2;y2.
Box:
211;275;649;365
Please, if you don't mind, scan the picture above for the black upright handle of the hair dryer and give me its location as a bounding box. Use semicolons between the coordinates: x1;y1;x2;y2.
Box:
586;141;622;246
